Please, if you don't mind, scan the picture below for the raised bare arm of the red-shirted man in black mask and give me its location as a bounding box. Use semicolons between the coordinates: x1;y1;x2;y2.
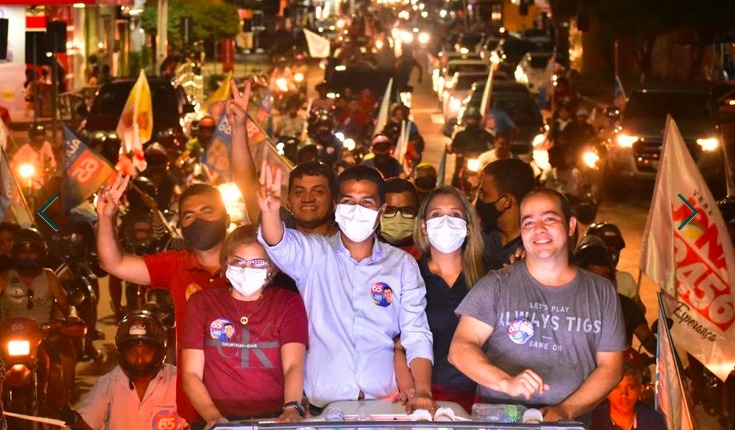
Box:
97;172;151;285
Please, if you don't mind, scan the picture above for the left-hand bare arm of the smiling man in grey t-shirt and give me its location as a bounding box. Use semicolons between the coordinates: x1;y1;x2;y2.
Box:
449;315;549;399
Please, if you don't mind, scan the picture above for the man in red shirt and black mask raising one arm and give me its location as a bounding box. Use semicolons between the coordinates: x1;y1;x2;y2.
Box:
97;178;230;422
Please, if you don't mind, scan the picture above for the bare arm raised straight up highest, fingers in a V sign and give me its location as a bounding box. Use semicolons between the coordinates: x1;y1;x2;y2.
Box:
231;79;260;224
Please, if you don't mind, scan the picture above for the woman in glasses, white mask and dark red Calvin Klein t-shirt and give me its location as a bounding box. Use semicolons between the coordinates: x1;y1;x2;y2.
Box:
181;225;308;429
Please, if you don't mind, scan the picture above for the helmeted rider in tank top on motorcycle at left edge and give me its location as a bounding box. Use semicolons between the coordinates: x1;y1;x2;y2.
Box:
0;228;75;411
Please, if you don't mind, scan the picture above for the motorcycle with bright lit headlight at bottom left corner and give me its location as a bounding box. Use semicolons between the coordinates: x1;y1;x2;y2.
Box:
0;317;86;429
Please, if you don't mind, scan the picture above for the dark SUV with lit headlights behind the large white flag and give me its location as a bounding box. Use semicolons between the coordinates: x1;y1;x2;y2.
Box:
604;83;726;198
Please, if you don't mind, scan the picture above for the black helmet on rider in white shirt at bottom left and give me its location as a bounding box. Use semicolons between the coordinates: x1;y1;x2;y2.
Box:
115;311;167;378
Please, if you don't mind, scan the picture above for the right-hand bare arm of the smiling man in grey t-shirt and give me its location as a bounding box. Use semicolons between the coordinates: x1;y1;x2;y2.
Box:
542;352;623;421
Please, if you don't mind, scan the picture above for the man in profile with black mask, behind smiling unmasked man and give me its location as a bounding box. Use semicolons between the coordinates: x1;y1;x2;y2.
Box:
475;159;536;270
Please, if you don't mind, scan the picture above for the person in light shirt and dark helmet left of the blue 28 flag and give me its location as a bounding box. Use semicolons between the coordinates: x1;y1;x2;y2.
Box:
11;123;56;189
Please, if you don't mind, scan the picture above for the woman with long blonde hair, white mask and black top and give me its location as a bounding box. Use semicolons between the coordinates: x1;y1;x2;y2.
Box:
414;187;485;411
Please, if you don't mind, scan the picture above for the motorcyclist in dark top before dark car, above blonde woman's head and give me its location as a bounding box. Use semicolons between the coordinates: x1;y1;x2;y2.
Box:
448;106;494;186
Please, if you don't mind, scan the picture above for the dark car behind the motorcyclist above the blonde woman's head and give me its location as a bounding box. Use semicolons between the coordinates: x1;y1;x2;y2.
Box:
444;79;543;160
